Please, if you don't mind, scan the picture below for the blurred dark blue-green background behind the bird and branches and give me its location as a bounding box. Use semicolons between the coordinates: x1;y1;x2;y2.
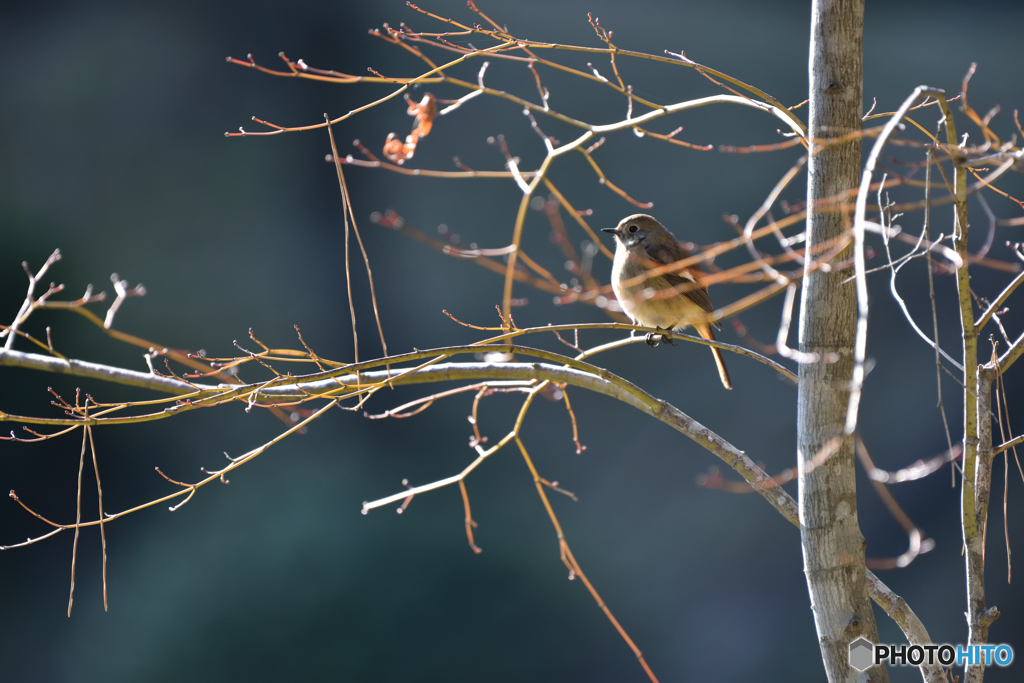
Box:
0;0;1024;681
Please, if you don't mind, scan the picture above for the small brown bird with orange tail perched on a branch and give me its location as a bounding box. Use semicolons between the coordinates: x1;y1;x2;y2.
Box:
602;213;732;389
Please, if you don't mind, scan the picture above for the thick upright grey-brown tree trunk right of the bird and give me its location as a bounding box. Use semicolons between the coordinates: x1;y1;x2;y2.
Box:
797;0;889;683
